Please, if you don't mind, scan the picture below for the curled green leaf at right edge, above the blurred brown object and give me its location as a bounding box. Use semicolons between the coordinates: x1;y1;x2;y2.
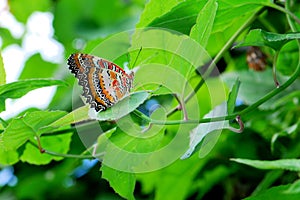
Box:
236;29;300;51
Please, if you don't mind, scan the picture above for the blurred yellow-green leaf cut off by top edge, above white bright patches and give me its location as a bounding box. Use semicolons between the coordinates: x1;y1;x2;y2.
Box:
8;0;51;23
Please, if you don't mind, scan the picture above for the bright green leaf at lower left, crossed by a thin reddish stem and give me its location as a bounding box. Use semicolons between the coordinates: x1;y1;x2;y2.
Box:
20;133;72;165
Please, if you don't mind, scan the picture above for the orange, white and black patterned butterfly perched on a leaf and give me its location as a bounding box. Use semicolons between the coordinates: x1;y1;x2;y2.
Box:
67;53;134;112
